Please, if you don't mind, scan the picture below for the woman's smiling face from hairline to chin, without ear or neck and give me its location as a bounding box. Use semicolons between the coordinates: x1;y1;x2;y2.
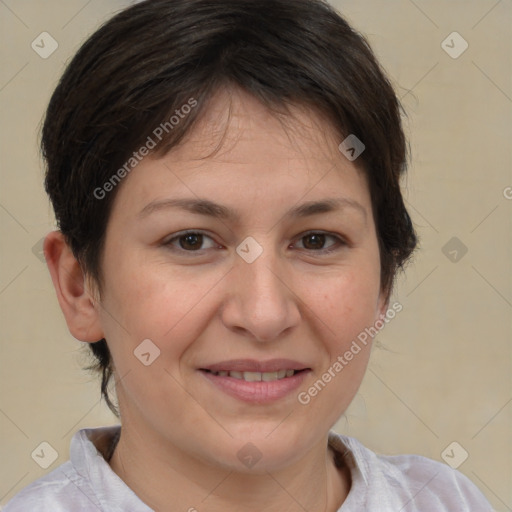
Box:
94;87;385;470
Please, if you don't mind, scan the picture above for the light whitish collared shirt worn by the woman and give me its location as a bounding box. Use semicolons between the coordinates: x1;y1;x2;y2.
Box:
3;425;492;512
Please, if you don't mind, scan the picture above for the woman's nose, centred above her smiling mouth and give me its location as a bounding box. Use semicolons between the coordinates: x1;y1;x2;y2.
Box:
221;245;301;342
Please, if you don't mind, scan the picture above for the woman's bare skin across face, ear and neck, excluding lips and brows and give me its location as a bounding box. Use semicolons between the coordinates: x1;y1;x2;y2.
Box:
45;90;387;512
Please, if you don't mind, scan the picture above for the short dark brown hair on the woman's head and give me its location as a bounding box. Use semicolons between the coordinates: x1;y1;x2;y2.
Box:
41;0;416;416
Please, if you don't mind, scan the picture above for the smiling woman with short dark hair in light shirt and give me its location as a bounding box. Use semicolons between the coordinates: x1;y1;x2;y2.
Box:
6;0;491;512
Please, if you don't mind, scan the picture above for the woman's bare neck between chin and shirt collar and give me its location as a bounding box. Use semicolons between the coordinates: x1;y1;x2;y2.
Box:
109;427;350;512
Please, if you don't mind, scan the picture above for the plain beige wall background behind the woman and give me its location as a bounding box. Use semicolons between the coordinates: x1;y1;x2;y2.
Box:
0;0;512;511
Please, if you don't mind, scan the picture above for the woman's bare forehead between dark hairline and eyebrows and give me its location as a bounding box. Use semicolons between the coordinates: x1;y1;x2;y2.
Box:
109;90;369;222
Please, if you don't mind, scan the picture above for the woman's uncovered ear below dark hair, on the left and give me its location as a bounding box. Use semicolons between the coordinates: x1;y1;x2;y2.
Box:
44;231;104;342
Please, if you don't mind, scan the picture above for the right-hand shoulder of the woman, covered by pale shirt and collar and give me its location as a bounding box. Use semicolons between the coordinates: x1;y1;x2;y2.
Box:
329;434;492;512
